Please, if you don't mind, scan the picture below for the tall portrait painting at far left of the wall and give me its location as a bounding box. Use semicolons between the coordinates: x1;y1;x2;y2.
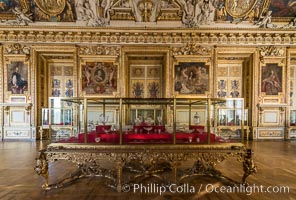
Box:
7;61;28;94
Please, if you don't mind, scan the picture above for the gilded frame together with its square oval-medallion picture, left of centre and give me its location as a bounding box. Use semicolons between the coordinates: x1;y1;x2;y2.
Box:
79;56;120;97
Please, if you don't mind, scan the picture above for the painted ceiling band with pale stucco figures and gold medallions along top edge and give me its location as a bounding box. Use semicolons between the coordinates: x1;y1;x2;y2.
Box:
0;0;296;22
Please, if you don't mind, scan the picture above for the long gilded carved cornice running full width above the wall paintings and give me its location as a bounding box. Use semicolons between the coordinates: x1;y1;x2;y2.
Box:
0;27;296;46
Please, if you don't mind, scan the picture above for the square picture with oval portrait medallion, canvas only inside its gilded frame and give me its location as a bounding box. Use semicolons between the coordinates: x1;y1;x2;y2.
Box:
81;61;118;96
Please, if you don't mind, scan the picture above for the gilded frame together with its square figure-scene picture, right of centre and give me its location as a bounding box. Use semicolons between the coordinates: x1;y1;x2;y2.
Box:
172;58;212;98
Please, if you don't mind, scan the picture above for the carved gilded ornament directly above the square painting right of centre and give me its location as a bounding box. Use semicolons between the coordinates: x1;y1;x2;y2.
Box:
172;43;211;56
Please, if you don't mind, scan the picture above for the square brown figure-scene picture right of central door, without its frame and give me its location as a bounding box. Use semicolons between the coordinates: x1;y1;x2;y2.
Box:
174;62;210;95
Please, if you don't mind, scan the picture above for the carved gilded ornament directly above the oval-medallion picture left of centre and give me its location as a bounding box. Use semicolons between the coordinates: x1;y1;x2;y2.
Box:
79;46;120;56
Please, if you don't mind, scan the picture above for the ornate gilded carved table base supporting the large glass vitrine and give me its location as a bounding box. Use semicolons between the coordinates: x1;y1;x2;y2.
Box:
35;144;256;191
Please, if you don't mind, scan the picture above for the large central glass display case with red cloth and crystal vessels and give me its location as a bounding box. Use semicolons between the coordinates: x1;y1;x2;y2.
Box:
43;97;245;145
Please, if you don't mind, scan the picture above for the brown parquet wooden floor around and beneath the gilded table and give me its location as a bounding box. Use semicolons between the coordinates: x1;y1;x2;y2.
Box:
0;141;296;200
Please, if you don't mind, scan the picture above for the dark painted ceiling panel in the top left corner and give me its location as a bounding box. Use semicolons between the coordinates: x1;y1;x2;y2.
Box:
0;0;28;20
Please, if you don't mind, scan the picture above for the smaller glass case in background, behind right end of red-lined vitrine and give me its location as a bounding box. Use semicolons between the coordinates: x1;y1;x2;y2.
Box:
217;98;248;139
